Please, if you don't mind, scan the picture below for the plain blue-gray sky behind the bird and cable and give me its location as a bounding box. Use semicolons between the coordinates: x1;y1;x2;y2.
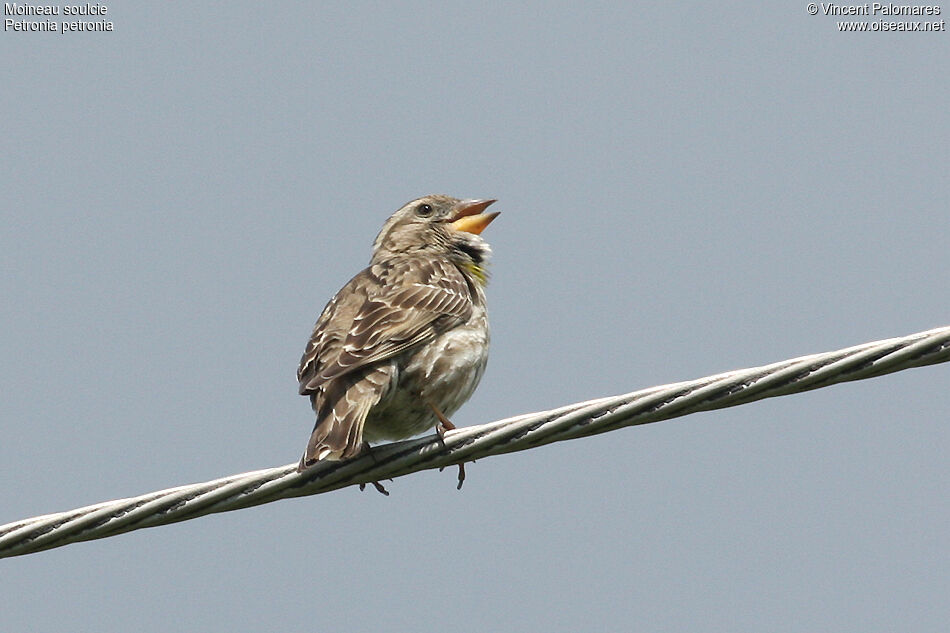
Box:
0;1;950;633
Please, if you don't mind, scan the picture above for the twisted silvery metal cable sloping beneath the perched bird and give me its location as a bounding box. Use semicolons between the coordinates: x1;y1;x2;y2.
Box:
0;327;950;558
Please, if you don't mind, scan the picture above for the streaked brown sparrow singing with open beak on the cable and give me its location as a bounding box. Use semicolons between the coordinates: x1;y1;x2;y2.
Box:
297;194;499;494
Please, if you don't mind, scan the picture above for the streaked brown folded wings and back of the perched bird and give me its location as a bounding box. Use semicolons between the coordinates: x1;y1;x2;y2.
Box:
297;258;472;394
